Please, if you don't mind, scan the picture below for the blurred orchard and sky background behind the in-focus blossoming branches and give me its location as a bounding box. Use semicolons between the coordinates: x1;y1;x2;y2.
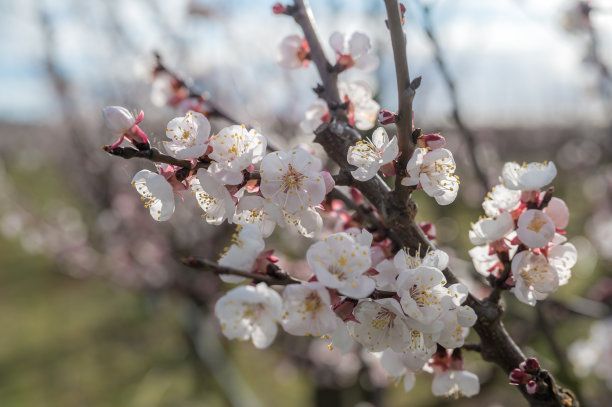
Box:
0;0;612;407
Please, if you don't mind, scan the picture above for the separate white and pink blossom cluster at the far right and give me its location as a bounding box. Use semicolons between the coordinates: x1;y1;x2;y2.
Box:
469;162;577;305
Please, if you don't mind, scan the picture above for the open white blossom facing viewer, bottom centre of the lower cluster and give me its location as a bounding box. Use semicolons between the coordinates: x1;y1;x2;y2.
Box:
348;298;410;352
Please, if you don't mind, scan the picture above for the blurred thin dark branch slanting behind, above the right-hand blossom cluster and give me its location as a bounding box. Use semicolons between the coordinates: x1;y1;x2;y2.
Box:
419;3;489;193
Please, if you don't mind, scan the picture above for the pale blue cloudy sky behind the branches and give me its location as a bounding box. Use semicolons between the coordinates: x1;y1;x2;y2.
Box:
0;0;612;126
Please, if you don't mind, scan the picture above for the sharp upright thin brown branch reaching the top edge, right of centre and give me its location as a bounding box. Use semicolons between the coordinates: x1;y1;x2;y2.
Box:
385;0;421;202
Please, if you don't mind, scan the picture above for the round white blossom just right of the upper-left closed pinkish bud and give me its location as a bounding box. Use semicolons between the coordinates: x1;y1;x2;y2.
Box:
164;111;210;160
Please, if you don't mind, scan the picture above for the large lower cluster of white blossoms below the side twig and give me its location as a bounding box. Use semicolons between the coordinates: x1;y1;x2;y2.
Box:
216;230;478;396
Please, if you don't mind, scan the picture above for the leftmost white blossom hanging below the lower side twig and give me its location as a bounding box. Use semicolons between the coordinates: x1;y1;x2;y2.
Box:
215;283;283;349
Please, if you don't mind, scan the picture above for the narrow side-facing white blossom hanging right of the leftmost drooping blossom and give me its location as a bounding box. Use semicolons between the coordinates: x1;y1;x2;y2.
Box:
191;168;236;225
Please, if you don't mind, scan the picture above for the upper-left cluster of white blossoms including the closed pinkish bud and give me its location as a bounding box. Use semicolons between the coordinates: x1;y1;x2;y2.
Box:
104;107;334;237
